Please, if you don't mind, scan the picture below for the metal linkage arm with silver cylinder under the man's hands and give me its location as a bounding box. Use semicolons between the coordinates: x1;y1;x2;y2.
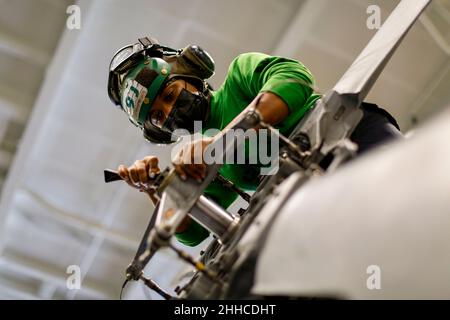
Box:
139;109;261;262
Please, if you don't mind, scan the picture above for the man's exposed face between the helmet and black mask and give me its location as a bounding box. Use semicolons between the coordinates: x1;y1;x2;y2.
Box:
150;79;198;128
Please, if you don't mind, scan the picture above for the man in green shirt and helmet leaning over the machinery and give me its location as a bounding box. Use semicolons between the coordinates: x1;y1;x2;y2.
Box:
109;38;398;246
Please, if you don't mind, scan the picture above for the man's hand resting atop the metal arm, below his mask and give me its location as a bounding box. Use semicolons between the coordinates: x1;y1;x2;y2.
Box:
172;137;213;182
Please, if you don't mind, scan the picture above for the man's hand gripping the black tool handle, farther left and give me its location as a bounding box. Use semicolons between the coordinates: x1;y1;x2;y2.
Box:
117;156;160;204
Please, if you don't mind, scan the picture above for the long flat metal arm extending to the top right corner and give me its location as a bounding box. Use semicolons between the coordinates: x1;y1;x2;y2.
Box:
290;0;431;167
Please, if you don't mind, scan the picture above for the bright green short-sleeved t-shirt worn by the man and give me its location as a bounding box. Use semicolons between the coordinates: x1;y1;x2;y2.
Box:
176;53;320;246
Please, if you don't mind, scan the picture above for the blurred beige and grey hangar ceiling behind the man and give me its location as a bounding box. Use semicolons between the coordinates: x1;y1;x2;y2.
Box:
0;0;450;299
